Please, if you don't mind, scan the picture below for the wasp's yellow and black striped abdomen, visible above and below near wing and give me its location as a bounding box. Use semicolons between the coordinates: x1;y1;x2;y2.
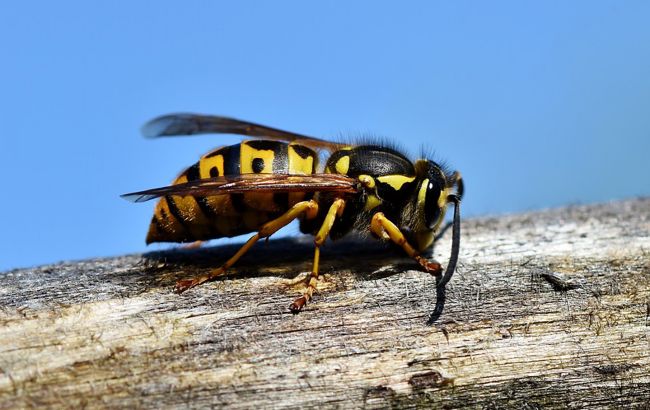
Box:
147;140;318;244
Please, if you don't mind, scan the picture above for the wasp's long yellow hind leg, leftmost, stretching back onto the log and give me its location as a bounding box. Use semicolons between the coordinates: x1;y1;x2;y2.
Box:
175;200;318;293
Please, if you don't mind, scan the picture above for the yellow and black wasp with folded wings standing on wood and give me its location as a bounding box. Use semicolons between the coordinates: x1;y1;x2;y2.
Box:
122;114;463;313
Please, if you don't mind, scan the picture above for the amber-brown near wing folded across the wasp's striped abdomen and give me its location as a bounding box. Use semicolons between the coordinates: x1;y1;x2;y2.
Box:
121;174;359;202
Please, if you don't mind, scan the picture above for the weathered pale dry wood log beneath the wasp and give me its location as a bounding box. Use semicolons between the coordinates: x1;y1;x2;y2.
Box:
0;199;650;408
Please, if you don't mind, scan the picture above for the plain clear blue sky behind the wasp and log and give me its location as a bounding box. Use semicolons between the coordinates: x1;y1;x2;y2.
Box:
0;0;650;270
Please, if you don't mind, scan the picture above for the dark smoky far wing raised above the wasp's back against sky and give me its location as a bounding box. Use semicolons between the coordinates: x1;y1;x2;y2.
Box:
142;113;341;151
